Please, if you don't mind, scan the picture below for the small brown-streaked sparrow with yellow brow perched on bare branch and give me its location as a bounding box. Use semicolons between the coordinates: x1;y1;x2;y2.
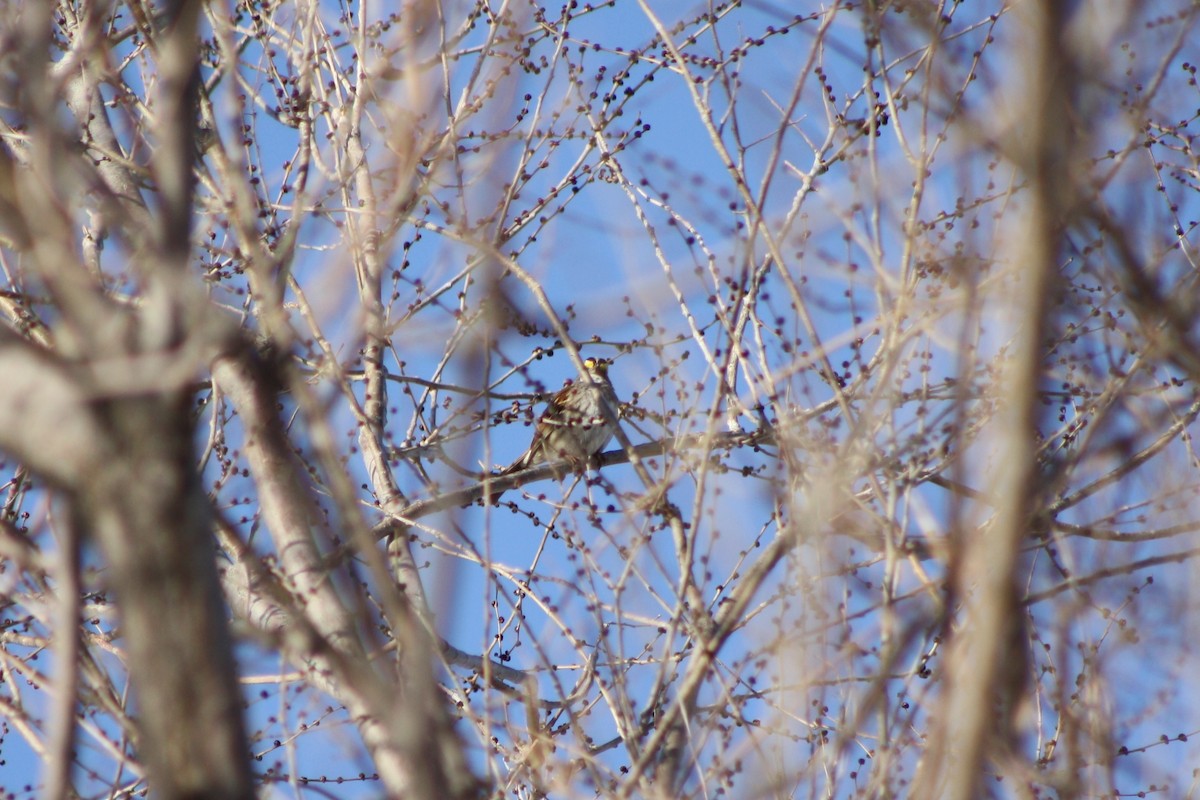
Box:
500;359;620;475
